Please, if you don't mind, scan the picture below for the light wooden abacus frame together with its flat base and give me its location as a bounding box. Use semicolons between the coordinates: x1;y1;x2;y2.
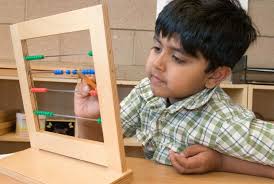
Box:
0;4;132;184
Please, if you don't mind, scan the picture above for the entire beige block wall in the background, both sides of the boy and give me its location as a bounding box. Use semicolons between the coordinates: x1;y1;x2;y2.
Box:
0;0;274;80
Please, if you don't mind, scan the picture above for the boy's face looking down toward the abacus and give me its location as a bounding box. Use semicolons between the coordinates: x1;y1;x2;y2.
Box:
146;35;212;99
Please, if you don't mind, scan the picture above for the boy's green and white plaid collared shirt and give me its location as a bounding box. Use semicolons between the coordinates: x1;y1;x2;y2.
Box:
121;78;274;166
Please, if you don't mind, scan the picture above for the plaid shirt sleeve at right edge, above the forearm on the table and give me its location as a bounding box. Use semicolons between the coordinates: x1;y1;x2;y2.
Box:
215;112;274;167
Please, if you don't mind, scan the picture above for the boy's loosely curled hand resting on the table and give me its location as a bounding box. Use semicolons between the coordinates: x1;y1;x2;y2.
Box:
169;145;222;174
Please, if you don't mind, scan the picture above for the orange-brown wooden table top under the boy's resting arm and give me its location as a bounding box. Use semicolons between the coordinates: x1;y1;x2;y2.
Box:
0;157;274;184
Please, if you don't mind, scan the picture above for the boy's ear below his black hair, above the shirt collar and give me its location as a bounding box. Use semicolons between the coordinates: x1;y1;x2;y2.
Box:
205;66;231;89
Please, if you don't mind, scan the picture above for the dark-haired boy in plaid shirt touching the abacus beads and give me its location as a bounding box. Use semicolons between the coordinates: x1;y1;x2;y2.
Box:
75;0;274;177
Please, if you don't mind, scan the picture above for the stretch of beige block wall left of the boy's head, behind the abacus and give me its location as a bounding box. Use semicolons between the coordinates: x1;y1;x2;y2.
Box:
0;0;156;80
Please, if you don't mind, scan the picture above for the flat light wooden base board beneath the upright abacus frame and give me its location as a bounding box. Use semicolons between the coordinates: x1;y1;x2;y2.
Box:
0;148;132;184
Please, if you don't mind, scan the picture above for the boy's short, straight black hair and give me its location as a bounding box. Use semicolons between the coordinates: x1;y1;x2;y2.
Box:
155;0;257;72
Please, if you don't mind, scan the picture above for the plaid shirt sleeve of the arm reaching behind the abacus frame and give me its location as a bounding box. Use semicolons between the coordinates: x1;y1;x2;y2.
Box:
120;83;142;137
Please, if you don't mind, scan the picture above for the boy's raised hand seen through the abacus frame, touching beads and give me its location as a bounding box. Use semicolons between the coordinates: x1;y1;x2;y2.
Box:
74;81;100;118
